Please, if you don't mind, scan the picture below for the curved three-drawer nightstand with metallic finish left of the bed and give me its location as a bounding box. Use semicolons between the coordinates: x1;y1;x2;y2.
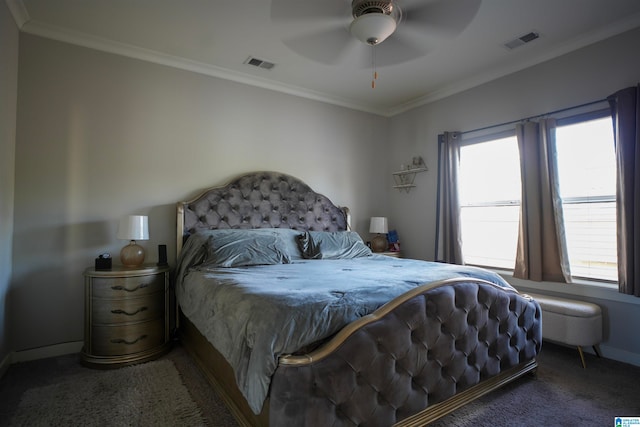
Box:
81;265;171;368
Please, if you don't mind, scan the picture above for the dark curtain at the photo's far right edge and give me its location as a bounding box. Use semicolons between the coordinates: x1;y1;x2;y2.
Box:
607;85;640;297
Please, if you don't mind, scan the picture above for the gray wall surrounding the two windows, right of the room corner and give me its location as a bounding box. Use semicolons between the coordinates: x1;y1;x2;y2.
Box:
389;29;640;365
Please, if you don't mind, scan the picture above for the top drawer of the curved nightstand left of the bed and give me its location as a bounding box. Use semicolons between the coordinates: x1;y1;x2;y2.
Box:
91;274;165;298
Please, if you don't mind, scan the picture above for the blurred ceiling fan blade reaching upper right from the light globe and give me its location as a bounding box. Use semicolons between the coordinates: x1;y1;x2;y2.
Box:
399;0;481;40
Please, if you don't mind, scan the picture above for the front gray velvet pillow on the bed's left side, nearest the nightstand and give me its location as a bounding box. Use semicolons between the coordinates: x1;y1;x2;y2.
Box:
202;229;291;267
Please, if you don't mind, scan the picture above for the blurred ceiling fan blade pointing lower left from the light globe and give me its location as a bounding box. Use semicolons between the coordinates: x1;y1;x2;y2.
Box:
283;28;360;65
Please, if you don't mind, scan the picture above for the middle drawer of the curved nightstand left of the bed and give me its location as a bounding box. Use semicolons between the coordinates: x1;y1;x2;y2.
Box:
91;292;165;325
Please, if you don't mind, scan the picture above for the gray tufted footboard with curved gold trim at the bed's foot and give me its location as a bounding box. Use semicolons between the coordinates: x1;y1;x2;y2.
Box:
269;279;542;426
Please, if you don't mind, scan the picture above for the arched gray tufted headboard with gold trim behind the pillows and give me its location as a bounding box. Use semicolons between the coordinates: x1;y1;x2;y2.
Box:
176;172;350;254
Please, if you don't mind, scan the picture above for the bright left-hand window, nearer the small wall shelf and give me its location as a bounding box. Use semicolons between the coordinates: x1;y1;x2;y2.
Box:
458;136;520;269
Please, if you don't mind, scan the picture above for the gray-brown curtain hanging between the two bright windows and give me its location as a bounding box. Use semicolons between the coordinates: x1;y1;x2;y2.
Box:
513;119;571;283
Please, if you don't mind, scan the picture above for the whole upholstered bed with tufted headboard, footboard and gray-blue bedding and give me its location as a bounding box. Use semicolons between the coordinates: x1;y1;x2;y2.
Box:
175;172;542;426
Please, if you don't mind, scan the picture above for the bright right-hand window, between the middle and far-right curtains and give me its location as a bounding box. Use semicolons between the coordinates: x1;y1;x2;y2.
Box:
556;117;618;281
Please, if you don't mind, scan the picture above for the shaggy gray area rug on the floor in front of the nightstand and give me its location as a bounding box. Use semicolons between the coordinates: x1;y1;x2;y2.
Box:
10;360;206;426
